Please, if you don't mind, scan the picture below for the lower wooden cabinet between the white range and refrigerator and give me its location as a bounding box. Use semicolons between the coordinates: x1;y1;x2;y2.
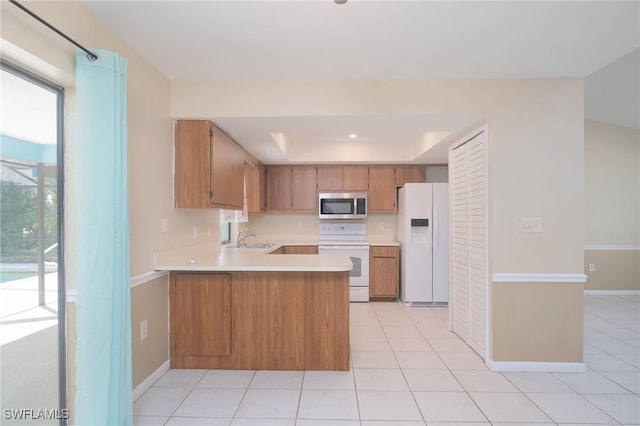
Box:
369;246;399;300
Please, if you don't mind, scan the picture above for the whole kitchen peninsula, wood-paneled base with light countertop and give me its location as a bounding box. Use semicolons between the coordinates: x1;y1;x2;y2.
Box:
155;245;353;370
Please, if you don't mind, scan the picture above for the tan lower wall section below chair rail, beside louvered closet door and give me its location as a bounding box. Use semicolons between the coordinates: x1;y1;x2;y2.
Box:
491;282;584;363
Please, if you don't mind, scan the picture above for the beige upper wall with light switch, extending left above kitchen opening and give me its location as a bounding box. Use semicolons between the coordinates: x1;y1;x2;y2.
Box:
171;79;584;273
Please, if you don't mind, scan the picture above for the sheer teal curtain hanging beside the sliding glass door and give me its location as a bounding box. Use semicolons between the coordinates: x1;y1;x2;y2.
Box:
74;50;133;425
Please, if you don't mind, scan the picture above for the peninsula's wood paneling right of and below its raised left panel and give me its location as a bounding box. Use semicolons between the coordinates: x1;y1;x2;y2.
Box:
171;271;349;371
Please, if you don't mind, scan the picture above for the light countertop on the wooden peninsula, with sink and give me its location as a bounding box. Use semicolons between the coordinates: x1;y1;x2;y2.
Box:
154;242;353;272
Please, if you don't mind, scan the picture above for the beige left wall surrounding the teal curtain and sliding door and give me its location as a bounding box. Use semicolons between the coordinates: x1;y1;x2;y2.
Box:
0;1;218;402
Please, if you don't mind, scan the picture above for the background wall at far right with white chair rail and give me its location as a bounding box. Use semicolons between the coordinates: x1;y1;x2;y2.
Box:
584;120;640;291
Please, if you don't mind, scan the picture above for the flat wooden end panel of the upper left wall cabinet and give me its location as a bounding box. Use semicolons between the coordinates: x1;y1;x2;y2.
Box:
173;120;211;209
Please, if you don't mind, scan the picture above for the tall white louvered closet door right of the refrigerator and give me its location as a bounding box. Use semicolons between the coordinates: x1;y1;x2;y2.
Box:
449;131;487;358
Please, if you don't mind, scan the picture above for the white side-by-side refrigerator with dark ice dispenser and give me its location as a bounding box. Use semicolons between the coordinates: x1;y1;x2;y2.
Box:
397;183;449;305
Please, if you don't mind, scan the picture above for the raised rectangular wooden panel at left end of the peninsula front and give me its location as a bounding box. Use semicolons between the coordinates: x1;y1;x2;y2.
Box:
170;274;231;356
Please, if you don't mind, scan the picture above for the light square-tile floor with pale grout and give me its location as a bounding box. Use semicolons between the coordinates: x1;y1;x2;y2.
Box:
134;295;640;426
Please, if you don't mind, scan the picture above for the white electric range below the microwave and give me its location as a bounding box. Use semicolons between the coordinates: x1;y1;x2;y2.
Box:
318;220;369;302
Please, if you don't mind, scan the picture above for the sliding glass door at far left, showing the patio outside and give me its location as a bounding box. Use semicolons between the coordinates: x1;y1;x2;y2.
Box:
0;61;68;425
